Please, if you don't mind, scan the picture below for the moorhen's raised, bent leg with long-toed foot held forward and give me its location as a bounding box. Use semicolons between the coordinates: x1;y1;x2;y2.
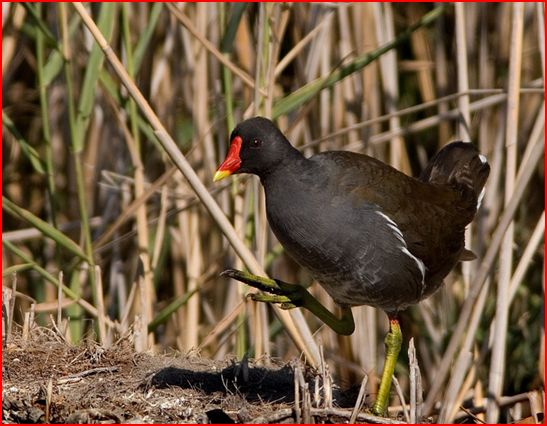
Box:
220;269;355;335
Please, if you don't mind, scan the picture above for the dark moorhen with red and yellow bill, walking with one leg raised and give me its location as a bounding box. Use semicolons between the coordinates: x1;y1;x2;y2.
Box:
214;117;490;415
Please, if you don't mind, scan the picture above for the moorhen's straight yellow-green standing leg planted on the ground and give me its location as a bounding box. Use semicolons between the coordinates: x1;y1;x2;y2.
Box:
372;317;403;416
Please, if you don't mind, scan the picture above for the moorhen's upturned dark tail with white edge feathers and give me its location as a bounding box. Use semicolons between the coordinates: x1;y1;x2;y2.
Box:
420;142;490;206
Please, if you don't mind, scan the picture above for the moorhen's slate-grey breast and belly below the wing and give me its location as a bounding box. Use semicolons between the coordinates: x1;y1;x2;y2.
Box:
266;181;425;311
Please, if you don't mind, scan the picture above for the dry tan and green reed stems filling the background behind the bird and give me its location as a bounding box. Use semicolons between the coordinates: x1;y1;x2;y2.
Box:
2;3;545;423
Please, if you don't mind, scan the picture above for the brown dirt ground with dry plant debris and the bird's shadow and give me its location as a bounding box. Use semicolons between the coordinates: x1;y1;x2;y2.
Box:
2;330;402;423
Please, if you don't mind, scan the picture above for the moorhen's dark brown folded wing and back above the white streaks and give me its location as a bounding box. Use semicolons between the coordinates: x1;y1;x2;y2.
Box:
313;151;469;294
